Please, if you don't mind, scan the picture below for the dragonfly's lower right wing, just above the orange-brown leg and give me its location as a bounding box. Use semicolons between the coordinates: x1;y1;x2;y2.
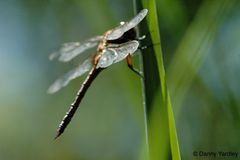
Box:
97;40;139;68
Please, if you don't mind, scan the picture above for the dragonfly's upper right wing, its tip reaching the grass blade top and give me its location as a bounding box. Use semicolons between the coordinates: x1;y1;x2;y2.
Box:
106;9;148;40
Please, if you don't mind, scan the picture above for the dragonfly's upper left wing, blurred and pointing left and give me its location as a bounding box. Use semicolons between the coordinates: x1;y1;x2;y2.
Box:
49;36;103;62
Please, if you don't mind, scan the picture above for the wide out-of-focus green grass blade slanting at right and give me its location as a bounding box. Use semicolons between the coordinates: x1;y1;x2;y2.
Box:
167;0;236;117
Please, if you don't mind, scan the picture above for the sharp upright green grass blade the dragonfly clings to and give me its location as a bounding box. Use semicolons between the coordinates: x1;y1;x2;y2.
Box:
134;0;181;160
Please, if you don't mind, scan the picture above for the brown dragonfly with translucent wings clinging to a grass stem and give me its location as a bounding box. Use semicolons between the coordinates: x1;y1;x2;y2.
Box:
48;9;148;139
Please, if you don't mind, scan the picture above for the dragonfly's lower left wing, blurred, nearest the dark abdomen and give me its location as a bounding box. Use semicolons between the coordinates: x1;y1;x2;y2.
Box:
47;58;93;93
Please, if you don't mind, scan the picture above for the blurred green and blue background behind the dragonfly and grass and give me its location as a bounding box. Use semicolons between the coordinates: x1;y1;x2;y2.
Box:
0;0;240;160
